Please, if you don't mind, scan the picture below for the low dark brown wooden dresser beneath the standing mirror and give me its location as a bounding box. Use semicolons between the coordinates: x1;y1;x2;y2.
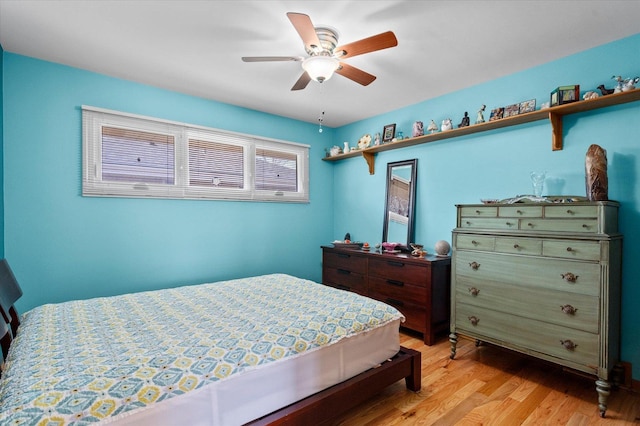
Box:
322;246;451;345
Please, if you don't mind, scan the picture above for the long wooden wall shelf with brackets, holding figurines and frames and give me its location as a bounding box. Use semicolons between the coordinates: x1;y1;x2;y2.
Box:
323;89;640;174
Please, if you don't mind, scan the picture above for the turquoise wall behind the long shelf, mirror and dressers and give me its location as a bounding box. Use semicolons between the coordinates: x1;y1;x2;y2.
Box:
333;34;640;379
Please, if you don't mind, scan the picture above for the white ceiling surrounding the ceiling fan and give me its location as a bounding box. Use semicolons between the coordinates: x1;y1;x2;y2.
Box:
0;0;640;127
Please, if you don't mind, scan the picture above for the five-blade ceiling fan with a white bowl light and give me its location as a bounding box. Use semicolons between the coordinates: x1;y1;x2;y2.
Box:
242;12;398;90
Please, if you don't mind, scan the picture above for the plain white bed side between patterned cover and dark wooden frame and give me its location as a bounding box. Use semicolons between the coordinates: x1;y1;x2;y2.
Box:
101;319;400;426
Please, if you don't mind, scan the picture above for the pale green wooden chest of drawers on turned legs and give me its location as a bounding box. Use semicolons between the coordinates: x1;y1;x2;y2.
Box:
450;201;622;416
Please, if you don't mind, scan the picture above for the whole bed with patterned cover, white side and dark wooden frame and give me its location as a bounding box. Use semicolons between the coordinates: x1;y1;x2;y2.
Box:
0;274;420;426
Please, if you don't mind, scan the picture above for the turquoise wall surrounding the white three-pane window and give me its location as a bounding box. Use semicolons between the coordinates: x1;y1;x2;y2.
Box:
4;52;333;312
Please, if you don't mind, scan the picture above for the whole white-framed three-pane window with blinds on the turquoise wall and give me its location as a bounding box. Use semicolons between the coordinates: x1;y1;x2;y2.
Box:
82;106;309;202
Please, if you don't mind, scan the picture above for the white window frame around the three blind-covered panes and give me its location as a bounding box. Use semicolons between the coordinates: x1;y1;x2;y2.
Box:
82;105;309;203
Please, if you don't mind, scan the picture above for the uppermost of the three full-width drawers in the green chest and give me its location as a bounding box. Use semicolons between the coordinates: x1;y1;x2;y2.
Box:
455;250;600;296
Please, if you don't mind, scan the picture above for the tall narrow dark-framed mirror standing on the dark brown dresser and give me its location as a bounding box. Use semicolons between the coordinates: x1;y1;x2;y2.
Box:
382;159;418;250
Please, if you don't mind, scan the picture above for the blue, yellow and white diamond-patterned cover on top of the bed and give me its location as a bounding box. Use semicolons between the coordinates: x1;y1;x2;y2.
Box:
0;274;402;425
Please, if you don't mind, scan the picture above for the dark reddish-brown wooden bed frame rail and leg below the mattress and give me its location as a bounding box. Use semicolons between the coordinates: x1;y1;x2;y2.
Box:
248;346;421;426
